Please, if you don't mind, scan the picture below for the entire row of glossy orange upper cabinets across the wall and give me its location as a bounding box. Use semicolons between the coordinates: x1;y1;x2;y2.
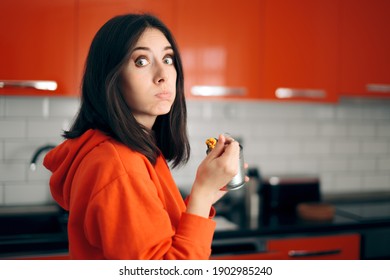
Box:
0;0;390;102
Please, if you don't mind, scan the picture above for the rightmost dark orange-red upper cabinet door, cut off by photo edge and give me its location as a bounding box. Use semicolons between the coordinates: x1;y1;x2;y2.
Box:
340;0;390;97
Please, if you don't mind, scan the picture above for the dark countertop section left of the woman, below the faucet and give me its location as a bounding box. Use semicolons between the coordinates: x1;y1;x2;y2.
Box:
0;205;68;259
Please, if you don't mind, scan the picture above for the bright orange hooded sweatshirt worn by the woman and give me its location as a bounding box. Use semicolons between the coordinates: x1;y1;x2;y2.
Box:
44;130;215;259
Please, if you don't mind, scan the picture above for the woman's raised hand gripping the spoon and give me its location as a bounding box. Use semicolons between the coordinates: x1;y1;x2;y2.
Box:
187;135;240;217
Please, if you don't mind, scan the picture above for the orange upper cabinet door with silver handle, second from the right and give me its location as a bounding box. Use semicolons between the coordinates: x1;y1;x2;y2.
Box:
262;0;339;102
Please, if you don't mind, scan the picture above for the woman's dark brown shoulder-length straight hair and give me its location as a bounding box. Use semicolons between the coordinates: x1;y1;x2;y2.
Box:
64;14;190;167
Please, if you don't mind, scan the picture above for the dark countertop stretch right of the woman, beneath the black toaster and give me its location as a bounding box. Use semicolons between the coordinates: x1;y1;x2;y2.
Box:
215;192;390;239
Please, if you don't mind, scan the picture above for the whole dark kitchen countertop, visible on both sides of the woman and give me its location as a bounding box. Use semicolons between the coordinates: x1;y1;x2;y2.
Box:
0;193;390;259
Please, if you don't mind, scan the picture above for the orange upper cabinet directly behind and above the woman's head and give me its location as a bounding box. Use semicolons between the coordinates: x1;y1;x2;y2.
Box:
77;0;174;89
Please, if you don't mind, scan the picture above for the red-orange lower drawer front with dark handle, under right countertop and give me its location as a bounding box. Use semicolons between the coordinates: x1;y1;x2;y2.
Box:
267;234;360;260
